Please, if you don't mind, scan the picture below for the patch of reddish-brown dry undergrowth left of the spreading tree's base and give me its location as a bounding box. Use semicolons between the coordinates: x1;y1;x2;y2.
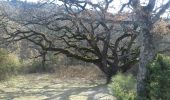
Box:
56;65;104;80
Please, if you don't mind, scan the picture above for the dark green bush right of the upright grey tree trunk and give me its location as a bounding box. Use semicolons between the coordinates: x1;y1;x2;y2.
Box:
148;54;170;100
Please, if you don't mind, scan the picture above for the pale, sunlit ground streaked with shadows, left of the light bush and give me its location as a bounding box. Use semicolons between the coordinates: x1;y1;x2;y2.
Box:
0;74;116;100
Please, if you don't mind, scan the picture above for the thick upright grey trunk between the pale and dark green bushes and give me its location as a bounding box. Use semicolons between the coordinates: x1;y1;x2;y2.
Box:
137;24;156;100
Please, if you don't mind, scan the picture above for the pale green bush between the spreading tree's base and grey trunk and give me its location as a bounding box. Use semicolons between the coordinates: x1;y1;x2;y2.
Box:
108;73;137;100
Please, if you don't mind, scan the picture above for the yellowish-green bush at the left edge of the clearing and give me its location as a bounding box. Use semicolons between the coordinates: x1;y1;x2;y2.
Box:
0;49;21;80
